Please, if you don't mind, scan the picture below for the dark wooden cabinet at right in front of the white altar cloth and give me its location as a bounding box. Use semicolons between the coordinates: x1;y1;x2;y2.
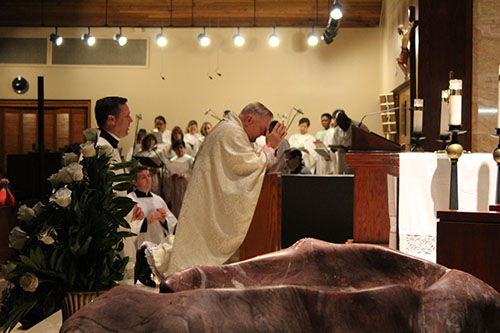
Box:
437;211;500;292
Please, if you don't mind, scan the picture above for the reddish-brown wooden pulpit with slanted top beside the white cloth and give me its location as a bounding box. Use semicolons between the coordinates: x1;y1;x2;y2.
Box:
346;126;401;244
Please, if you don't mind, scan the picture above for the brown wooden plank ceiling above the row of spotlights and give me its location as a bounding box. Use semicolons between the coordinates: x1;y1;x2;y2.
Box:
0;0;382;28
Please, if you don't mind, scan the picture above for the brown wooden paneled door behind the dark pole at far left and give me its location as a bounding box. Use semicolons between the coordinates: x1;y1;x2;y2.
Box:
0;100;90;173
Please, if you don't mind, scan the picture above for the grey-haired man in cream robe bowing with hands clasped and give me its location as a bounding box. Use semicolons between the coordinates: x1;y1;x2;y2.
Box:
147;103;286;280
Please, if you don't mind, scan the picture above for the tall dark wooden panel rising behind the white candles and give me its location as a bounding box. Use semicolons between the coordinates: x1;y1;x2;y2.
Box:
418;0;473;151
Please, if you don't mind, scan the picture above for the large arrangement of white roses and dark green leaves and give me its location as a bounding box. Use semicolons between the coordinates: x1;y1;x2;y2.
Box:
0;129;135;332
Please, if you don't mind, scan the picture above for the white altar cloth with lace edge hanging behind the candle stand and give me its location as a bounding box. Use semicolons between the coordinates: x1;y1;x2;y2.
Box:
398;153;498;262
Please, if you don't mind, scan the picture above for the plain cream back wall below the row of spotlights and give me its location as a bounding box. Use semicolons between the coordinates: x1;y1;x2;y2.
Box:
0;28;383;148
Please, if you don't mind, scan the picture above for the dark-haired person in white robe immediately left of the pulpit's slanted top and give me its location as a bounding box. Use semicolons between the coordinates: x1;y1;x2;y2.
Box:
332;110;369;174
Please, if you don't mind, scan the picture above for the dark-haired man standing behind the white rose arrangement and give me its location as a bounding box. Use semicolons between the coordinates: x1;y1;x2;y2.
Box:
95;96;143;275
